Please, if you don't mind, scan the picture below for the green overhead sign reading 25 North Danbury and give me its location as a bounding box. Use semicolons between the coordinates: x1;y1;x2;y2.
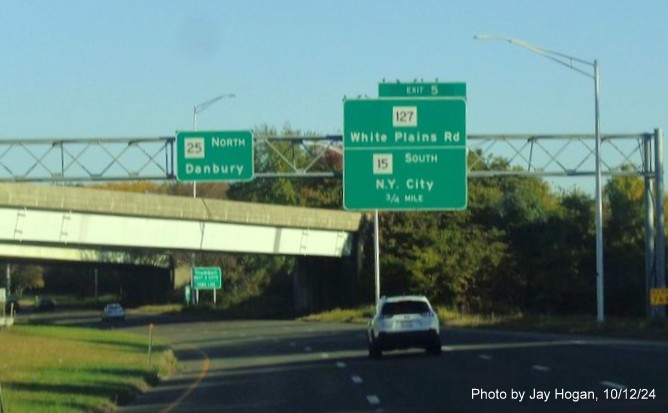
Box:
176;131;255;181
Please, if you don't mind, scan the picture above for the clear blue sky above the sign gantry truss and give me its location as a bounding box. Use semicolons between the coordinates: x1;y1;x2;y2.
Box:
0;0;668;189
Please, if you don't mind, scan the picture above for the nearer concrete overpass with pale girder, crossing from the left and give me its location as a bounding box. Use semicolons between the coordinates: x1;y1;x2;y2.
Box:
0;183;362;262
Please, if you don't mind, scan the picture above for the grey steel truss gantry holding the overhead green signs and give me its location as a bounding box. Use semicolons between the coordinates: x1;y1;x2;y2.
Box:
0;129;666;313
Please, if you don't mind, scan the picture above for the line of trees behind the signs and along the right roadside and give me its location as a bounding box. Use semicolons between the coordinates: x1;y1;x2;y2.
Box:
227;128;646;316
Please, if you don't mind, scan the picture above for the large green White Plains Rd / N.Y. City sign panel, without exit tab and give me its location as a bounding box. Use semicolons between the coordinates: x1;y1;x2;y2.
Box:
343;97;467;210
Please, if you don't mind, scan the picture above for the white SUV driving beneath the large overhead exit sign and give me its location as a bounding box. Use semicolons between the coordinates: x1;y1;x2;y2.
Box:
367;295;441;358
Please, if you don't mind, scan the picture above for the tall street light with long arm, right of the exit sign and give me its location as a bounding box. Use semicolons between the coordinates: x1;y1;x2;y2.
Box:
473;35;605;323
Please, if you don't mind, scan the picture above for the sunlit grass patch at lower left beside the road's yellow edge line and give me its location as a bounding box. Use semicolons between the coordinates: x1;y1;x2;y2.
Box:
0;325;176;413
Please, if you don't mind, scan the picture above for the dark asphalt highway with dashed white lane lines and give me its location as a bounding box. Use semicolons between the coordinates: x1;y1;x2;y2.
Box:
105;317;668;413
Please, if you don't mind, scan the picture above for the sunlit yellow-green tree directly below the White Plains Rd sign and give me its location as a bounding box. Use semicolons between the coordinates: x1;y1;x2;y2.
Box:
381;211;505;310
